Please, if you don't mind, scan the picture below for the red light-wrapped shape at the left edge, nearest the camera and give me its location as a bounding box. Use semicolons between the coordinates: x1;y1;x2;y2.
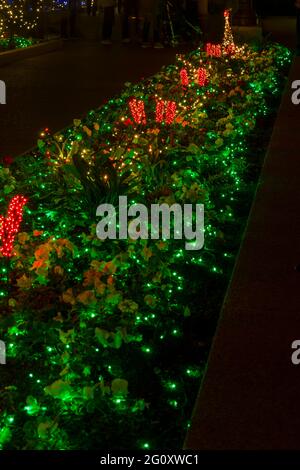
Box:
0;196;27;258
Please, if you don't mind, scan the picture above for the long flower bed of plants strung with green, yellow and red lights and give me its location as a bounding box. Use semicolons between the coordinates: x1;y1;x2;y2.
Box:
0;25;290;450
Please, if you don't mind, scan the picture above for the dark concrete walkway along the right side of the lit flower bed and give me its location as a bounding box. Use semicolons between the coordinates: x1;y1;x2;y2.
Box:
186;58;300;450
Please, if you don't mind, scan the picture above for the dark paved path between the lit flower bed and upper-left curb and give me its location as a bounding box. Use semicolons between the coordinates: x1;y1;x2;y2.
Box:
0;41;184;157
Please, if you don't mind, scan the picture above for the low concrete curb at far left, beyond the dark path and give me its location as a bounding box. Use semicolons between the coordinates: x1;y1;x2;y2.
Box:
0;39;63;67
